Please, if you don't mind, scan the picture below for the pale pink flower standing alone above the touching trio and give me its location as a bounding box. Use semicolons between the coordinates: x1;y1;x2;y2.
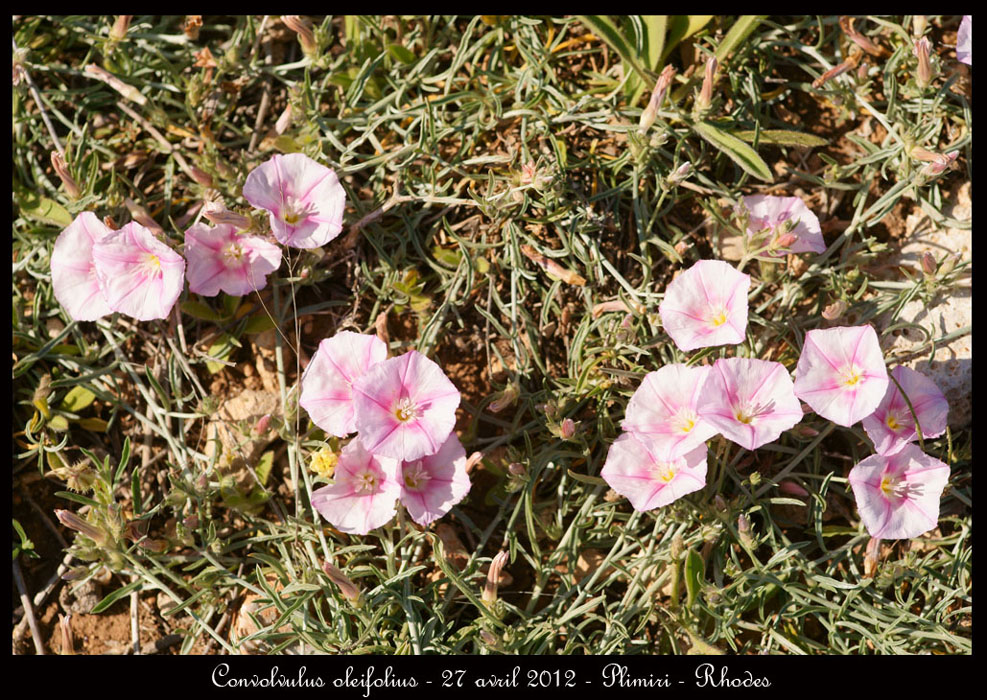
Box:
658;260;751;351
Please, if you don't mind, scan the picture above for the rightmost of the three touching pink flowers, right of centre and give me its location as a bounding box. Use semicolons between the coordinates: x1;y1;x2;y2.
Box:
699;357;802;450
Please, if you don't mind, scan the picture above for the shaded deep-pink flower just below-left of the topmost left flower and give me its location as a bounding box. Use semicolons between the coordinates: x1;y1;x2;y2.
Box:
185;223;281;297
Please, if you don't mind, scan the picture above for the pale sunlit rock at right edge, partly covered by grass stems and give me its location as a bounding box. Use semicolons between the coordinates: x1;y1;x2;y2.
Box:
880;182;973;428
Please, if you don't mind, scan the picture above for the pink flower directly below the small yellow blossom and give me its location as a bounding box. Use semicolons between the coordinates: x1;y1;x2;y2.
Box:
312;438;401;535
